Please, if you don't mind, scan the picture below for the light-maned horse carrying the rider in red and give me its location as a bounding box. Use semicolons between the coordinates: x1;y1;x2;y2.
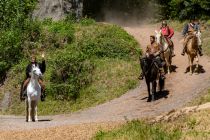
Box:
155;31;172;74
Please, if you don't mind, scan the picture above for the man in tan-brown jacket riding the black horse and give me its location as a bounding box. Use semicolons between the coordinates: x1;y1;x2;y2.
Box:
139;35;165;80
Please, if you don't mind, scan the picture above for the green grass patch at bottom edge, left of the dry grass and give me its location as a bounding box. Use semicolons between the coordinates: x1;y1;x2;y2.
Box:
93;121;181;140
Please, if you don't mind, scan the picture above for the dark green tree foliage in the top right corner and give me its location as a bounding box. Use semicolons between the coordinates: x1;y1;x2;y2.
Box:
158;0;210;20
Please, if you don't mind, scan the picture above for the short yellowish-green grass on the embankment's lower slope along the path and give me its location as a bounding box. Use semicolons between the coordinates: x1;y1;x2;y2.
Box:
4;58;139;115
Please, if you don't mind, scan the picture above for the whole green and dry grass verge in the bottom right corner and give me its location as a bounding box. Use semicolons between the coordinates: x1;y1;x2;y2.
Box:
92;110;210;140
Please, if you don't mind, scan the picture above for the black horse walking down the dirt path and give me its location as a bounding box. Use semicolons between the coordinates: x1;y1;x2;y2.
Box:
140;57;165;102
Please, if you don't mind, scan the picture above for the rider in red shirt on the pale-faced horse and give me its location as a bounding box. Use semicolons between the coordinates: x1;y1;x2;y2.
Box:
160;21;175;57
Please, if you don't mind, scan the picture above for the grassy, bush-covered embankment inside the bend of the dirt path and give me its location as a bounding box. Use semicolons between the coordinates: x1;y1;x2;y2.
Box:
1;19;141;115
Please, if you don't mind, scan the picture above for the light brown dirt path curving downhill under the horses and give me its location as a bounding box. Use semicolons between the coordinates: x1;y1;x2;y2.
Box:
0;25;210;138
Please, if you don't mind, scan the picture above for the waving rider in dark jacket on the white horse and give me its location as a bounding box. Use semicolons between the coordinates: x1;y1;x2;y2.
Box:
21;54;46;101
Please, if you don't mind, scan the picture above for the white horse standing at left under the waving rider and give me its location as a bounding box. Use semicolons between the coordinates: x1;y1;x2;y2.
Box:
26;66;42;122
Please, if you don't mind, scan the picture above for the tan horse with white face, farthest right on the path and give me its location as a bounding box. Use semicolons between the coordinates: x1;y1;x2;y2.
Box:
186;31;201;74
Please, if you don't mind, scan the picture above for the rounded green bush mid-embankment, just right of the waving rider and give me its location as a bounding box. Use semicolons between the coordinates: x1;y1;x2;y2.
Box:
48;46;94;100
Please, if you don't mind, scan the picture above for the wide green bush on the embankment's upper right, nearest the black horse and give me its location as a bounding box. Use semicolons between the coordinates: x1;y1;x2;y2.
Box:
78;25;141;59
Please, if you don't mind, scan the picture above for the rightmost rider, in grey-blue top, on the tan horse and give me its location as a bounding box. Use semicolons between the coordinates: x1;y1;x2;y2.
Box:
181;17;203;56
